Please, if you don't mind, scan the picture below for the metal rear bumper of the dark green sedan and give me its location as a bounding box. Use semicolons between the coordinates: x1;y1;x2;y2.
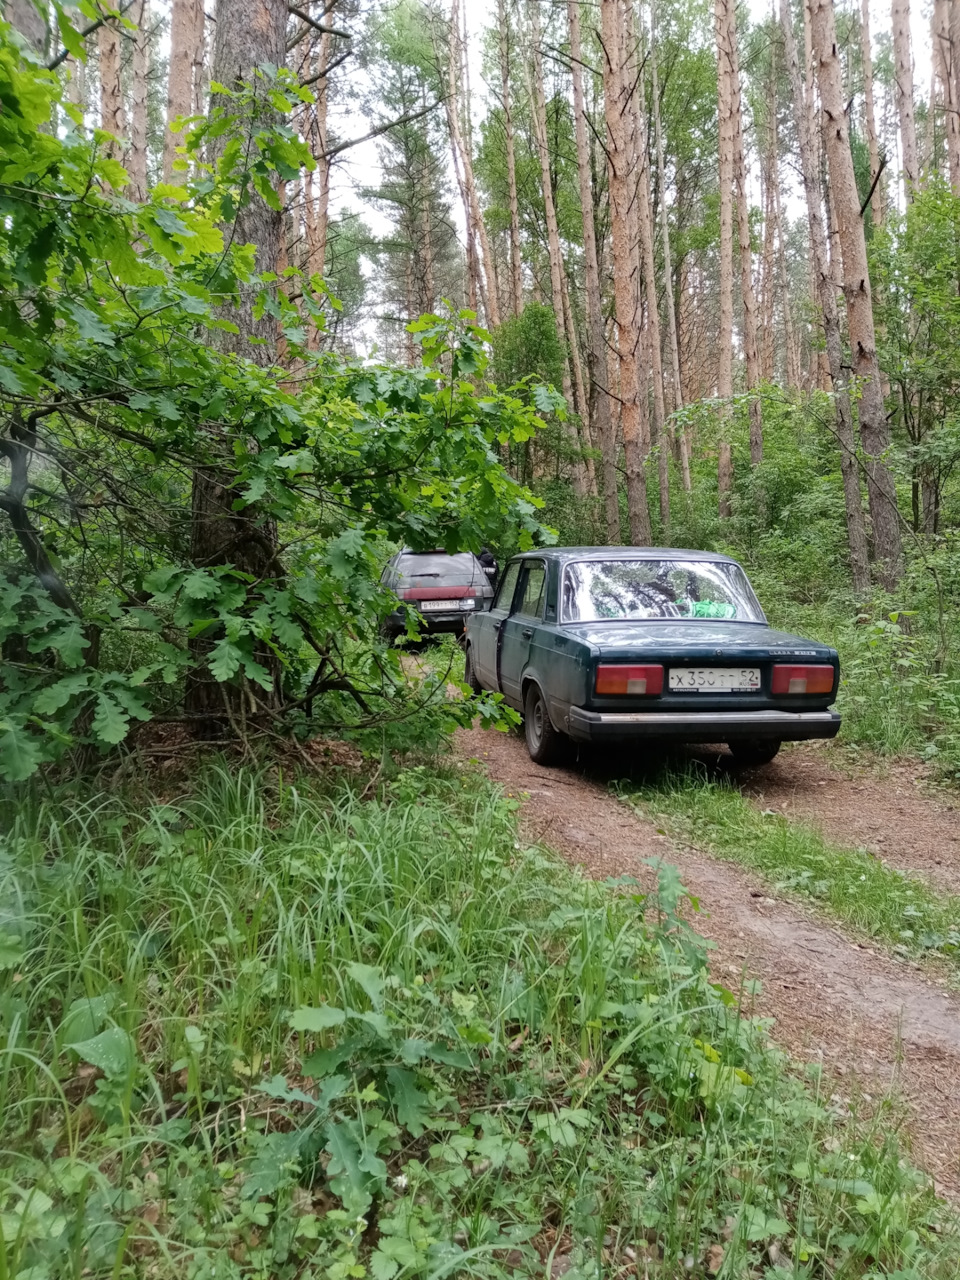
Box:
562;707;840;742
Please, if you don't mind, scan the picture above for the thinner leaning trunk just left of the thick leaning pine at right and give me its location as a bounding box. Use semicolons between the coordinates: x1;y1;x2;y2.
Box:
780;0;870;595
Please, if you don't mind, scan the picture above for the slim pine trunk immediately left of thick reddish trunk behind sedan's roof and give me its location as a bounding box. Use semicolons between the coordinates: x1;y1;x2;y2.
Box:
567;0;621;535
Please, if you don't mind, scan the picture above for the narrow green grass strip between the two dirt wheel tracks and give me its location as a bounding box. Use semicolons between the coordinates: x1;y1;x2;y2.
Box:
621;765;960;966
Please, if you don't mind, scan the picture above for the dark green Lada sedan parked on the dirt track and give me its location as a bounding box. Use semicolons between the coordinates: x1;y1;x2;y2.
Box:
465;547;840;764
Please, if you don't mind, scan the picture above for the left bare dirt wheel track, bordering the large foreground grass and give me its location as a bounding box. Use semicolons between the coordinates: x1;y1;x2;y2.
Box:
457;728;960;1197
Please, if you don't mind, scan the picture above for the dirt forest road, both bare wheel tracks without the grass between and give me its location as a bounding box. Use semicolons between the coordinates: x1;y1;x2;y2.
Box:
457;728;960;1198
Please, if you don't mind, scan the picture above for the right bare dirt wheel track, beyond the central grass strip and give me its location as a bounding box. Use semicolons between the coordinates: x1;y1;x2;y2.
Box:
741;742;960;893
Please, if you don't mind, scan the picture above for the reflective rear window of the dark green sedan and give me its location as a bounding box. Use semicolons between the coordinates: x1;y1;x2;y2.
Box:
563;559;765;622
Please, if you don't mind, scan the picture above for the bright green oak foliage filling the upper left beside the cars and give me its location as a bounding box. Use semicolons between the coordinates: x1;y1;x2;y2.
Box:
0;26;553;781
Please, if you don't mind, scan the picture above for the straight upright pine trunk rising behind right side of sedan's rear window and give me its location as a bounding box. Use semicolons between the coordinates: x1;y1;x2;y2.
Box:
713;0;733;517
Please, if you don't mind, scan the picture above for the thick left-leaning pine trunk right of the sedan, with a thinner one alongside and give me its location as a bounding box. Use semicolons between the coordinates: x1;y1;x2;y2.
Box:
812;0;902;591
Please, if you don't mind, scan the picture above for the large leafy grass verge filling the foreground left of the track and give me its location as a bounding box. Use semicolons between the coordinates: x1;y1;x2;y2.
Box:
0;768;960;1280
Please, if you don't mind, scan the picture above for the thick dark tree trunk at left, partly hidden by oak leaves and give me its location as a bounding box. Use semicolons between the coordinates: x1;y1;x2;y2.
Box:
187;0;287;732
